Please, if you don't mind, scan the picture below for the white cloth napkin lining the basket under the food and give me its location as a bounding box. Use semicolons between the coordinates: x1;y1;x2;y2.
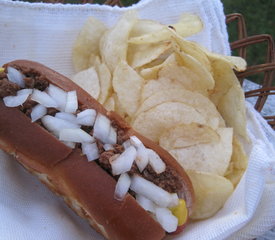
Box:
0;0;275;240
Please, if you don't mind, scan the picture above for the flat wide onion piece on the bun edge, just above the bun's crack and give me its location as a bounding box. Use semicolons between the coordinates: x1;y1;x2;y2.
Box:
59;128;95;143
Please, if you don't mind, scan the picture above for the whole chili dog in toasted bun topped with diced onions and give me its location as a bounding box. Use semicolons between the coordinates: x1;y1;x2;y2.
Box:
0;60;194;240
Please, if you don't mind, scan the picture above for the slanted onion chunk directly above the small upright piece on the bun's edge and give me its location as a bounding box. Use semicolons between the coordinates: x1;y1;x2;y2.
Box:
110;146;137;175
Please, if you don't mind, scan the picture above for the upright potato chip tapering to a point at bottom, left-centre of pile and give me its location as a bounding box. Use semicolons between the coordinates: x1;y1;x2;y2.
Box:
113;62;143;116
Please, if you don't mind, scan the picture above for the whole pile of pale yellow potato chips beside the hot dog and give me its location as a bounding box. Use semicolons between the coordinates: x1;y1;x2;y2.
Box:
73;11;250;219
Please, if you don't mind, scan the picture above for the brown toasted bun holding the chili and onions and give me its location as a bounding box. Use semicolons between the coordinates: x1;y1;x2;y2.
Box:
0;60;194;240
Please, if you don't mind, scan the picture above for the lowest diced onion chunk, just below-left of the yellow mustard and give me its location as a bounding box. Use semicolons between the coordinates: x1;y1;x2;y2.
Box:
156;208;178;233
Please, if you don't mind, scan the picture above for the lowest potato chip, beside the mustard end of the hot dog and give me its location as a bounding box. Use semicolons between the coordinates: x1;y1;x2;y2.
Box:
186;170;234;220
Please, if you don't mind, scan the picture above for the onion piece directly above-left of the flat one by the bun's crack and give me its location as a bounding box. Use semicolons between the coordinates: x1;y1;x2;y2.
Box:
41;115;80;137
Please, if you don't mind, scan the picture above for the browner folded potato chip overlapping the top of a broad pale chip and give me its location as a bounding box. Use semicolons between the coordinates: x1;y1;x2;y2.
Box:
159;123;220;151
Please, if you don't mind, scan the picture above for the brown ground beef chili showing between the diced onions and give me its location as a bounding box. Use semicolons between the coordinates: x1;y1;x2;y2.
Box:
0;67;183;194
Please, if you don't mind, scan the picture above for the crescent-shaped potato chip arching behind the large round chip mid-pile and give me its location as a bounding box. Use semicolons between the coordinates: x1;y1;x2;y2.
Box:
136;88;225;129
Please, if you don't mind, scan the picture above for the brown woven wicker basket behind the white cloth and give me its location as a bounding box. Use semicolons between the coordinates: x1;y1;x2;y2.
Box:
26;0;275;129
